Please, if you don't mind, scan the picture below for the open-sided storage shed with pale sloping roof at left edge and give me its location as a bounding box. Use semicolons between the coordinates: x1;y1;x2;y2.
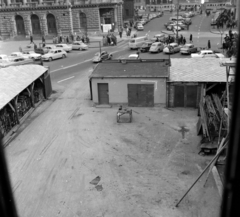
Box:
0;65;52;136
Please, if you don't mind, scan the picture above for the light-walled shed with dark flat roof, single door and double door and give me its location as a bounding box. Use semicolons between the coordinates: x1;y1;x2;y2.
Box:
89;59;170;107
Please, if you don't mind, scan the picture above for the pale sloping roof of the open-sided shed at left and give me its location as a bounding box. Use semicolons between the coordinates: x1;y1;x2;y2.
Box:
0;65;48;109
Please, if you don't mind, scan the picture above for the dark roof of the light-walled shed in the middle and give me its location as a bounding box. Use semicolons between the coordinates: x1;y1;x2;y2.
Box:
90;60;170;78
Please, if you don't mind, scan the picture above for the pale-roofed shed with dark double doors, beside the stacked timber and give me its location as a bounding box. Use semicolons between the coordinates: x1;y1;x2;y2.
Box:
167;58;226;108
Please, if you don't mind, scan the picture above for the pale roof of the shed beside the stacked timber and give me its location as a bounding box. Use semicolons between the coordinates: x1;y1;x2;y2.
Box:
169;58;227;82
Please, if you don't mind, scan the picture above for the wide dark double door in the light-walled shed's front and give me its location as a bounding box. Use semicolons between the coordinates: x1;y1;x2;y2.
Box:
128;84;154;107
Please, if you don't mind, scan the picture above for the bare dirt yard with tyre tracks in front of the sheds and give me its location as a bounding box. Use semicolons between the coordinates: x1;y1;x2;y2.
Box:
5;68;220;217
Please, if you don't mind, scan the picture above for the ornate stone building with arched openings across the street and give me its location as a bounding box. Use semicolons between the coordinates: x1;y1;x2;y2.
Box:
0;0;123;38
